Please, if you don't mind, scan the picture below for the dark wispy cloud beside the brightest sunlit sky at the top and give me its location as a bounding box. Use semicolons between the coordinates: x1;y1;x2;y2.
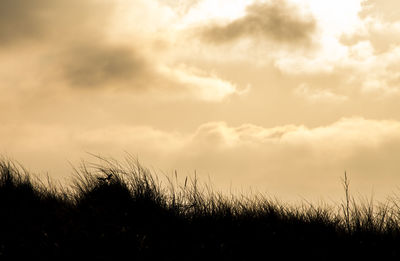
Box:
202;0;316;44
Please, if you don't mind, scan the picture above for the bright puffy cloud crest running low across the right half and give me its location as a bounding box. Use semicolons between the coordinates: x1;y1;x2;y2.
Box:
188;117;400;150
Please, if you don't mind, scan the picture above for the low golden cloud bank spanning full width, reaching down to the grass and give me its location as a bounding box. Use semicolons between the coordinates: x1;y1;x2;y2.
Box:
0;117;400;198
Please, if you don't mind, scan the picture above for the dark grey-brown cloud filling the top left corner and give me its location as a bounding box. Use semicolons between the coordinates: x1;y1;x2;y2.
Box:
0;0;111;46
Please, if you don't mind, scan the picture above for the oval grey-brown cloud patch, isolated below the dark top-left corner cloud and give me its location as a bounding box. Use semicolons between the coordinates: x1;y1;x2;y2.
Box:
62;43;147;87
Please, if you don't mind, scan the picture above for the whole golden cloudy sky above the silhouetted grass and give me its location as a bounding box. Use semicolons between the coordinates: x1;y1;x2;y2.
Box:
0;0;400;201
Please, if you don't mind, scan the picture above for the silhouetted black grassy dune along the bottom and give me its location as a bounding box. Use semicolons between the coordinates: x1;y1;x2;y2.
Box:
0;155;400;260
